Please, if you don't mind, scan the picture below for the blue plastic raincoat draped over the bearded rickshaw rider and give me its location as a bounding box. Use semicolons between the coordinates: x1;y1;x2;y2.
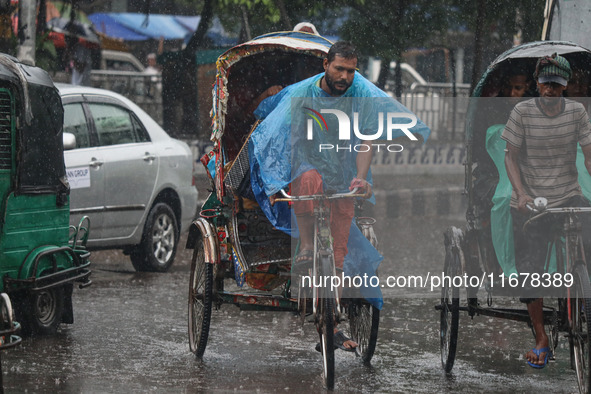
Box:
249;72;430;308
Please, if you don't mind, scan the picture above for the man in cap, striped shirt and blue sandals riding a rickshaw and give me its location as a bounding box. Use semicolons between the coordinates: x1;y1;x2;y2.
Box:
502;54;591;368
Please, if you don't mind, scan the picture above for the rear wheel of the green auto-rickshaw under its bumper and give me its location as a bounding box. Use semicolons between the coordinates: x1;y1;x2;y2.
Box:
21;286;64;335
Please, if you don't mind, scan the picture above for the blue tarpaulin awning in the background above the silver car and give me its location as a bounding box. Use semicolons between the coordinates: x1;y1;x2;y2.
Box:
88;12;236;46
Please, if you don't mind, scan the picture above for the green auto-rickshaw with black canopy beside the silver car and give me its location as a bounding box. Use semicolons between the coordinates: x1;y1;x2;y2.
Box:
0;54;91;334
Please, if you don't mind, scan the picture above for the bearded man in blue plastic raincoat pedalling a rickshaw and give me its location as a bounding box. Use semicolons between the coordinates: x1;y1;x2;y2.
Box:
249;42;429;350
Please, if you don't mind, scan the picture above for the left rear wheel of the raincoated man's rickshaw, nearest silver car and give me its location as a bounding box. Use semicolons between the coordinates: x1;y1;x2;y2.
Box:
189;242;213;358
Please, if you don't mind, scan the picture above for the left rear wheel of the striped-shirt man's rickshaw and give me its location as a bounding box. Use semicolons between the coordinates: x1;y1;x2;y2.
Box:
439;247;460;373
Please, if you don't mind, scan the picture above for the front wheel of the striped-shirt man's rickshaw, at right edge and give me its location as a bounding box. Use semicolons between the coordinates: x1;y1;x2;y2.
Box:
570;262;591;393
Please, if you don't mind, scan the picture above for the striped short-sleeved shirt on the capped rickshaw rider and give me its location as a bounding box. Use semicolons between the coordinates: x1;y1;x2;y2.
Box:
501;98;591;208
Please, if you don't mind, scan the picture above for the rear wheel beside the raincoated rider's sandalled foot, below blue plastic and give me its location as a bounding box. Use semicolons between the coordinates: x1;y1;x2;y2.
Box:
349;299;380;363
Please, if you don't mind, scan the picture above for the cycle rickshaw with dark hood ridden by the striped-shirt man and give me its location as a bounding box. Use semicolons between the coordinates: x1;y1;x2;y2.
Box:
436;41;591;393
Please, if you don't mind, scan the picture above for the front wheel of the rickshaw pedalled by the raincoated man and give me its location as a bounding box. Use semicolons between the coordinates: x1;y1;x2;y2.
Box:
316;257;335;390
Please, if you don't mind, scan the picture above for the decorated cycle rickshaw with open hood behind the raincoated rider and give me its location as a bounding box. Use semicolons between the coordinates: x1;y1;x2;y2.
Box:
187;32;379;389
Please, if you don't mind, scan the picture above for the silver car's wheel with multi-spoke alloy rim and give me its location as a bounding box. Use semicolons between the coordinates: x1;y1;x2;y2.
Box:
130;203;179;272
